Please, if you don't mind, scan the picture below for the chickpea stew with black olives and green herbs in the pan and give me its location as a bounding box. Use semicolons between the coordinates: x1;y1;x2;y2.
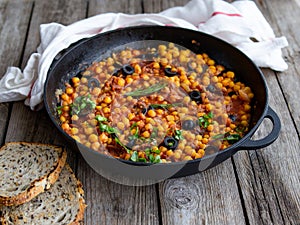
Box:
56;40;254;163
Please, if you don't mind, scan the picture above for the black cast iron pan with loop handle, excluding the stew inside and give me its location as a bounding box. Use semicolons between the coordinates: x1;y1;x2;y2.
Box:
44;26;281;185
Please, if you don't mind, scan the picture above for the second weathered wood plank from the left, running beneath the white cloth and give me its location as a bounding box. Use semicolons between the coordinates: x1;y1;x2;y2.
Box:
5;0;86;168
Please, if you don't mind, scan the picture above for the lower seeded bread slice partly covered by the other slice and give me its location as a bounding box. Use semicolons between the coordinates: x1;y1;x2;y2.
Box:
0;164;86;225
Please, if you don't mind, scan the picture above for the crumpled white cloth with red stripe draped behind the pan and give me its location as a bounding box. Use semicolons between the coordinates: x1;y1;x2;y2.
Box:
0;0;288;110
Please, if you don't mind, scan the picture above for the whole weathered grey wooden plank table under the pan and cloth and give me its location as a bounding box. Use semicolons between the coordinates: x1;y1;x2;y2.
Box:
0;0;300;225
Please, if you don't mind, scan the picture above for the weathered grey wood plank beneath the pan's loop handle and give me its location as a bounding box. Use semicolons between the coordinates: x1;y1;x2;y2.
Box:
234;70;300;224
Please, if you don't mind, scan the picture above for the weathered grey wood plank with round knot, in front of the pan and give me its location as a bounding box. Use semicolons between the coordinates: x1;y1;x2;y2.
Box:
159;159;245;225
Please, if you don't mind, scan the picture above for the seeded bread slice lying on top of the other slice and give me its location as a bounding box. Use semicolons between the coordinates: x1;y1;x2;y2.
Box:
0;142;67;206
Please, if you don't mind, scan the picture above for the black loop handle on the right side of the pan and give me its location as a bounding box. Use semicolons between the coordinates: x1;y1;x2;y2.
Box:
239;107;281;150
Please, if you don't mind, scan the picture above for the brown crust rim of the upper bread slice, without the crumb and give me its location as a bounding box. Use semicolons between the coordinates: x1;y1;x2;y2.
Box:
0;142;67;206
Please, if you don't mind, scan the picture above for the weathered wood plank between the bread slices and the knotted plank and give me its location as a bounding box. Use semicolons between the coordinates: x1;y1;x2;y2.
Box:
78;158;159;225
